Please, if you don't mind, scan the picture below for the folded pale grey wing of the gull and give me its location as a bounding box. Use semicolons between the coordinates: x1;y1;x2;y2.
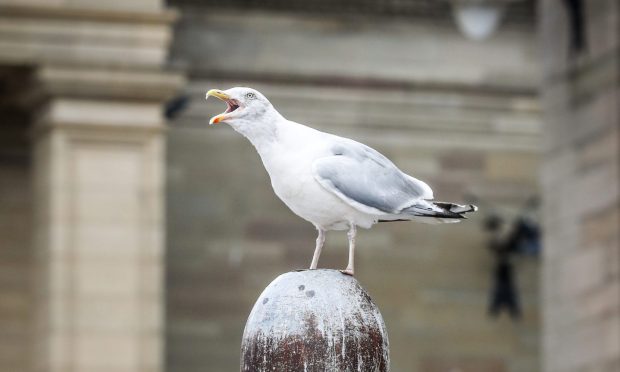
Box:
313;141;433;214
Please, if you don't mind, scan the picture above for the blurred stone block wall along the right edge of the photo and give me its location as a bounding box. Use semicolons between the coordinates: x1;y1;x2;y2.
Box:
539;0;620;372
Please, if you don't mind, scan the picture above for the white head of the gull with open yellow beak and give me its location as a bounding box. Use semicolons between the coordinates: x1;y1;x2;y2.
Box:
206;87;277;129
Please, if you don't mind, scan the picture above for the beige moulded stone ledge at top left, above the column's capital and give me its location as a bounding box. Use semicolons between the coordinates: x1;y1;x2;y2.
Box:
0;0;175;68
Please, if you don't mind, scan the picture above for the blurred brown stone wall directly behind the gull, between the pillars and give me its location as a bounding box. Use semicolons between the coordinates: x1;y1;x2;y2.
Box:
166;9;540;372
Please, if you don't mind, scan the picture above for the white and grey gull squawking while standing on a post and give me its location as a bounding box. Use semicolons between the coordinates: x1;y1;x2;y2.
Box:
206;87;478;275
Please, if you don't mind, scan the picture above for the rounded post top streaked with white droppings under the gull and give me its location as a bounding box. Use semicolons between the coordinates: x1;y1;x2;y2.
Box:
241;270;389;372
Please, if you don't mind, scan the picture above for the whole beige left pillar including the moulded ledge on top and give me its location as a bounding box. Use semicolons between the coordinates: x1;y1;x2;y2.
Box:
0;0;183;372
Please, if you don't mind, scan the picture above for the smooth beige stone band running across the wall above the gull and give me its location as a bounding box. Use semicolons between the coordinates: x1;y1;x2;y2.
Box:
172;8;539;89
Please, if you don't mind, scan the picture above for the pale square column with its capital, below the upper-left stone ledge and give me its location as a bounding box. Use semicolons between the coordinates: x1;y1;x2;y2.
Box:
34;70;177;371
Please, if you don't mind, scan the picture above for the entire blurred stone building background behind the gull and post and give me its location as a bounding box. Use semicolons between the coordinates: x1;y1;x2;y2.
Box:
0;0;620;372
